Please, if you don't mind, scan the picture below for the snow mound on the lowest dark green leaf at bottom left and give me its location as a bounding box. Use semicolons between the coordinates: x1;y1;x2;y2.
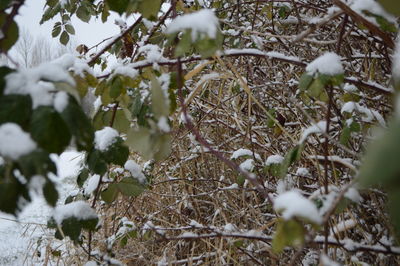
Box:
53;200;97;225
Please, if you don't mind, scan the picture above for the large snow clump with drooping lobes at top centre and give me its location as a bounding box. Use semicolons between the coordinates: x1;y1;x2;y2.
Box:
165;9;219;41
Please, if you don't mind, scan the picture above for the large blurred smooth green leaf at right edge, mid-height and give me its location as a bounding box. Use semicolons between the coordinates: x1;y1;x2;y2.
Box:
359;119;400;189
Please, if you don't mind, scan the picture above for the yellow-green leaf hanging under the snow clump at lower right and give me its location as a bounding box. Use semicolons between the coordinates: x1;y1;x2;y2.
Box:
272;219;305;253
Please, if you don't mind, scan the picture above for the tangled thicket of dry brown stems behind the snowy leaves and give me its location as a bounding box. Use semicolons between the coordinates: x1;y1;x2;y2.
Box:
89;1;399;265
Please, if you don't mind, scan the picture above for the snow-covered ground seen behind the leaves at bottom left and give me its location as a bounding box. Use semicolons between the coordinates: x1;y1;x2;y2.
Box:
0;151;83;266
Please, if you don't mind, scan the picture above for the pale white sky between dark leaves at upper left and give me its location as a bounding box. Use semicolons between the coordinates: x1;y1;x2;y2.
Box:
16;0;122;47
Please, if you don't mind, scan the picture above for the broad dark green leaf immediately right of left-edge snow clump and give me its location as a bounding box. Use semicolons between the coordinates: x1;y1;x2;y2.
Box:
30;106;71;154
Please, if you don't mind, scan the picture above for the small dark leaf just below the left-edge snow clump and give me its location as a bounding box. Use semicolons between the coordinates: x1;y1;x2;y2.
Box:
17;150;57;178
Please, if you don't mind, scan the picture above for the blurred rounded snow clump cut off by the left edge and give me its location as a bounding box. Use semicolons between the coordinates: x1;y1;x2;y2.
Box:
0;123;36;160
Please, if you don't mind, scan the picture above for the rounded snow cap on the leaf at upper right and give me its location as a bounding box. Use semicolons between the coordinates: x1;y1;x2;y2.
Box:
306;52;344;76
